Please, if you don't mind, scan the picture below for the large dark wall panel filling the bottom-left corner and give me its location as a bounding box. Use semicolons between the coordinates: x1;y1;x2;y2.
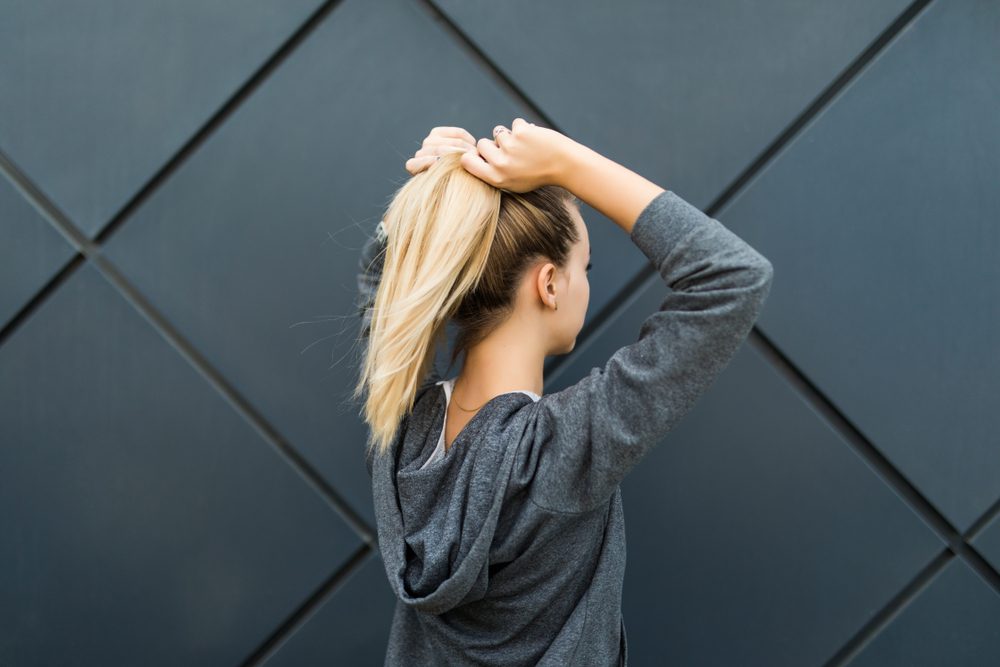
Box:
0;265;359;666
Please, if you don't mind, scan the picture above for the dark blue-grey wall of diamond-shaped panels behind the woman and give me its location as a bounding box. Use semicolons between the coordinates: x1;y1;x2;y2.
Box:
0;0;1000;667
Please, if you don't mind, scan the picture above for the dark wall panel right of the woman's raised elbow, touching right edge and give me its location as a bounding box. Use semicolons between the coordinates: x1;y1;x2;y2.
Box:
722;0;1000;531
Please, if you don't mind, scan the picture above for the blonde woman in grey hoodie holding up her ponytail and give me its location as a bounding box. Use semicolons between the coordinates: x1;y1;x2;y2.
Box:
355;118;772;667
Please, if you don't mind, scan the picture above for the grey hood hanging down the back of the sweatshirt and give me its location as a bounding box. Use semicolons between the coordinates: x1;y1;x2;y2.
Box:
369;382;534;614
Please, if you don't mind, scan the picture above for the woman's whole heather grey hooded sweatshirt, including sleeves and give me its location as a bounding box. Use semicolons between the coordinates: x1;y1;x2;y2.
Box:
358;190;772;667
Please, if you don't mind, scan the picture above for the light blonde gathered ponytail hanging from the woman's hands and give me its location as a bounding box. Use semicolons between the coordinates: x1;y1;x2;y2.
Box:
354;152;500;462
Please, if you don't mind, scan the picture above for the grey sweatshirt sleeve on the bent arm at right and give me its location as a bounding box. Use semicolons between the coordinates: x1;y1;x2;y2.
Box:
530;190;773;512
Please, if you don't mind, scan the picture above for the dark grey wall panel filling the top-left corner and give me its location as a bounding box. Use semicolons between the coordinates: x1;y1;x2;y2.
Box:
0;0;319;236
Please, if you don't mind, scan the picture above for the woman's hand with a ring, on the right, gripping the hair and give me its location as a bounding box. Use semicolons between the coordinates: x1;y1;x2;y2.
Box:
461;118;576;192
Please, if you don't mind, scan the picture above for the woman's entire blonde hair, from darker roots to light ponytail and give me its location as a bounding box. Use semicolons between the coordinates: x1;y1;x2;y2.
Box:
354;152;580;462
